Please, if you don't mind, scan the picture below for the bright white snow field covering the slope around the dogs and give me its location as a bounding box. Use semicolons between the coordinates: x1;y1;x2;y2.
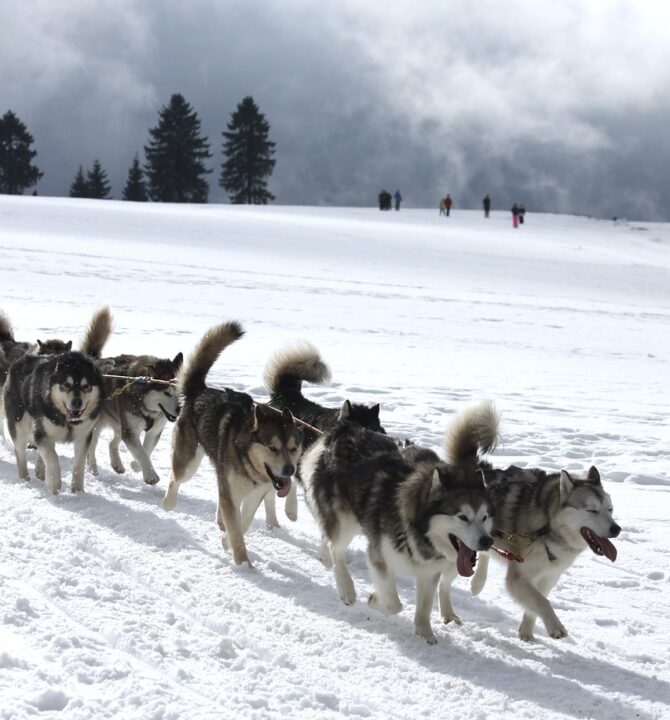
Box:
0;197;670;720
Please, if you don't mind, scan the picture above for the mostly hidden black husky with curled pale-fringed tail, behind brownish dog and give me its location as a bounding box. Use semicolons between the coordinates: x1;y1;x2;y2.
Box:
263;342;386;528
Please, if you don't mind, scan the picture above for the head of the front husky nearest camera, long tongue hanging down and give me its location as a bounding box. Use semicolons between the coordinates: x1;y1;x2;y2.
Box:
424;463;493;577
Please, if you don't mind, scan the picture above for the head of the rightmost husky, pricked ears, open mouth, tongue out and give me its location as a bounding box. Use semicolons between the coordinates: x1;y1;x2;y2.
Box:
560;467;621;562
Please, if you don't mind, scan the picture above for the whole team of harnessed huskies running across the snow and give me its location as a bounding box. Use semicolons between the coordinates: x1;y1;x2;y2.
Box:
0;307;621;644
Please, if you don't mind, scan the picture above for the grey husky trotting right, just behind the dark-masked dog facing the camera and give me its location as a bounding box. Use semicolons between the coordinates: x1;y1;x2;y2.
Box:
88;353;184;485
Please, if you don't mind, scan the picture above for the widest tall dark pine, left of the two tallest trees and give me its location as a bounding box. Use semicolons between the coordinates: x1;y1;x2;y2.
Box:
144;93;212;203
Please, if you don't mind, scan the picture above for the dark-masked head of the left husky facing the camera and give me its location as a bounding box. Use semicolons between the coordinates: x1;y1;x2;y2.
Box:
49;352;104;425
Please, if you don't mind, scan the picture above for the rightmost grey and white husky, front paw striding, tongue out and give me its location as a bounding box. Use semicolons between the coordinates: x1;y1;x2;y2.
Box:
460;456;621;640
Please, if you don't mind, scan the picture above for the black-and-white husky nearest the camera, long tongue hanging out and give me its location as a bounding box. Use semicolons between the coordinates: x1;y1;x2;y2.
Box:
298;401;497;645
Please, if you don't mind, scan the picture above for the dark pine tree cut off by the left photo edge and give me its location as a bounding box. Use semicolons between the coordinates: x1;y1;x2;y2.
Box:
0;110;44;195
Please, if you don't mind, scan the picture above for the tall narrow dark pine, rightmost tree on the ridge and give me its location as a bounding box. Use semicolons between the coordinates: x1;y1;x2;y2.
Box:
219;96;277;205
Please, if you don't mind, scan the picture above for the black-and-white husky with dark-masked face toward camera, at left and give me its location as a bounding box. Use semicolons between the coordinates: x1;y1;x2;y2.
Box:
3;307;111;495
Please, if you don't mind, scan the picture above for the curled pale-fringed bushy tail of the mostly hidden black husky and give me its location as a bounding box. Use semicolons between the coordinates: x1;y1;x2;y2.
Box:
263;342;330;397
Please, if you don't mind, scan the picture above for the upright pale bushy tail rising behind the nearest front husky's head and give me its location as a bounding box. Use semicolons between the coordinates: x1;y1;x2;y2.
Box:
444;400;500;465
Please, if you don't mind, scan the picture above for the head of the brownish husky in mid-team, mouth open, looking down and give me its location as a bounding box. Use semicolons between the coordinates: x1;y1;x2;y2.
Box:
249;405;303;497
